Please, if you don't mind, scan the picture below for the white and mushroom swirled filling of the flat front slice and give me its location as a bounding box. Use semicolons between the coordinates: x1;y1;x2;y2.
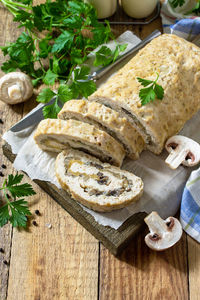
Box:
64;157;133;197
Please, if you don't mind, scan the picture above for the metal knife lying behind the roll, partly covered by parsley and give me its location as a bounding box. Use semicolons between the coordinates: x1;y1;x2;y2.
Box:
10;30;161;132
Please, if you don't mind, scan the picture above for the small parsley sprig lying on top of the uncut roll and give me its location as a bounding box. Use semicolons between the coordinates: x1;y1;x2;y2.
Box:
137;73;164;105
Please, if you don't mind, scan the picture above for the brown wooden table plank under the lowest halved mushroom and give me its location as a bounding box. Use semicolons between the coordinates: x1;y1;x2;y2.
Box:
99;232;189;300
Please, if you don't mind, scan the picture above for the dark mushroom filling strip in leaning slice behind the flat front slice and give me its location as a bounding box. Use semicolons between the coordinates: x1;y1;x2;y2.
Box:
40;136;112;162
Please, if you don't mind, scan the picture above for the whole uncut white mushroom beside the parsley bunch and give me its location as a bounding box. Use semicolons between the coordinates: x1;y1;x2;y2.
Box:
0;72;33;104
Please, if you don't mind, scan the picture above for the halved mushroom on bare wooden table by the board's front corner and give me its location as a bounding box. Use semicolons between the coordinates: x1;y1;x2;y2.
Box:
144;211;183;251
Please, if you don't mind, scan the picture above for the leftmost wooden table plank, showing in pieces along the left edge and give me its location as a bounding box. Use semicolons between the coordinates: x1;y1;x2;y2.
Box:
0;5;23;300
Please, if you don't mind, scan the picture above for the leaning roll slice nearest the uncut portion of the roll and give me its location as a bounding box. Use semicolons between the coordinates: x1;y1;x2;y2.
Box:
58;100;145;159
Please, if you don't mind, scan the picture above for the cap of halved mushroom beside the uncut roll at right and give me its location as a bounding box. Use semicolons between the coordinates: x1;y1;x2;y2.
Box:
165;135;200;167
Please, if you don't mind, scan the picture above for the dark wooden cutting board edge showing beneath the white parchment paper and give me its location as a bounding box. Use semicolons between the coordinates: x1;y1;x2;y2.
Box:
3;143;146;255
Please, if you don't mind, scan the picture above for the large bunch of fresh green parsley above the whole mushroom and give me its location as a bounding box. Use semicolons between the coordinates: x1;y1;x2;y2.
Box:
0;0;126;118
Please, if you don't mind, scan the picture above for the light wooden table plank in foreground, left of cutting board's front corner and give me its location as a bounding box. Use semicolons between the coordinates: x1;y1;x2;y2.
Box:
3;67;99;300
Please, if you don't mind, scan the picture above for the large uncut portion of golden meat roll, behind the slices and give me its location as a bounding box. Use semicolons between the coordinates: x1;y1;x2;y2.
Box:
89;34;200;154
